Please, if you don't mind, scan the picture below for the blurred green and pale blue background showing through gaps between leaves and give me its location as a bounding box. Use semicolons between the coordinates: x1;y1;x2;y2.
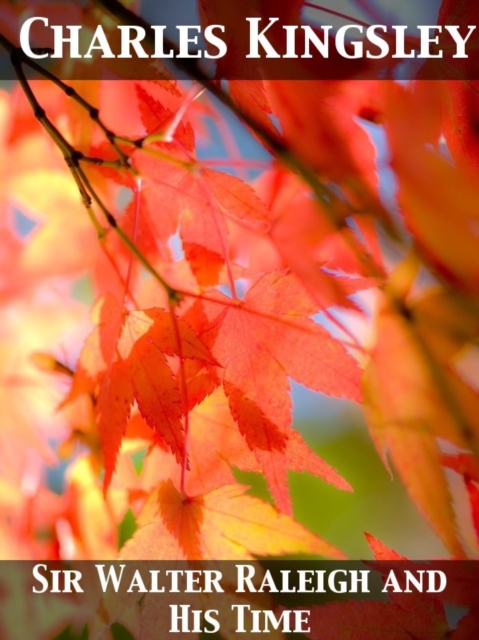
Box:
3;0;468;559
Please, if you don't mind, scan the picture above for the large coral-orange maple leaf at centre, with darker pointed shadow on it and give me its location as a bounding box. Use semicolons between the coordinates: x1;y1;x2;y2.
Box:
187;274;360;511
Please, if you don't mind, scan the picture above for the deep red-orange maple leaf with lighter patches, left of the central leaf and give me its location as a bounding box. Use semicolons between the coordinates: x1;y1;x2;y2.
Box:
68;296;217;489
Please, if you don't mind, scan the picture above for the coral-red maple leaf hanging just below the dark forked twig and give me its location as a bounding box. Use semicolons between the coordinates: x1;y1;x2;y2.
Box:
134;152;269;285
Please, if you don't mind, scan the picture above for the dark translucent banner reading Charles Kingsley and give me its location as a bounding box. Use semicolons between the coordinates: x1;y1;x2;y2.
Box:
0;0;479;81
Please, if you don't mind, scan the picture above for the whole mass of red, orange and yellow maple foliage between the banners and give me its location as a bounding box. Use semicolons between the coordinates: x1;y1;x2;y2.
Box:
0;0;479;584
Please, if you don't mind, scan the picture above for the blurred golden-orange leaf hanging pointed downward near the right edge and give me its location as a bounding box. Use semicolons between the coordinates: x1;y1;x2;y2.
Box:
363;290;465;556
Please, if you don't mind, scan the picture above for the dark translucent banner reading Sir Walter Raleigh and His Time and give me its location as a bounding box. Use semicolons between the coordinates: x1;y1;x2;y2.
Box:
0;561;479;640
